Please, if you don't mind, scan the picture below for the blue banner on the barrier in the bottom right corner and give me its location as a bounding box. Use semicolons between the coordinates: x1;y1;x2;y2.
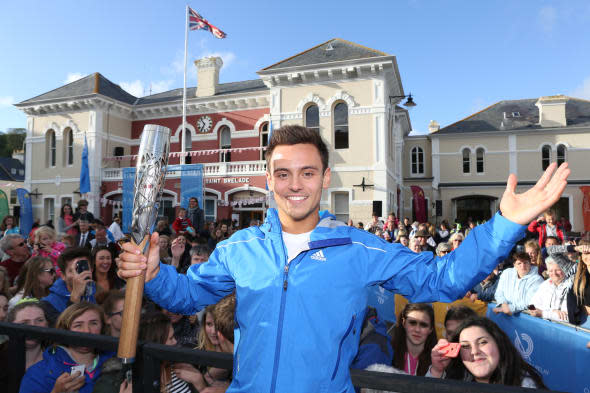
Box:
487;304;590;393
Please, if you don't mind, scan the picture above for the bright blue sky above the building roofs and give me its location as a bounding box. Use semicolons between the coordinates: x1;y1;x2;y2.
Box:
0;0;590;133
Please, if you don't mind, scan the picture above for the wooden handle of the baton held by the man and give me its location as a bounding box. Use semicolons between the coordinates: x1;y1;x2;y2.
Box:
117;235;149;363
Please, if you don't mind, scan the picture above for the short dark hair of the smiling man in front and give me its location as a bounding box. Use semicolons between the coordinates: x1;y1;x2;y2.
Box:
266;125;330;171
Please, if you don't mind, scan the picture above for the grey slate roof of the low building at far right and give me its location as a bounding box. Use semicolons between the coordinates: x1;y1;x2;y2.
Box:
440;98;590;135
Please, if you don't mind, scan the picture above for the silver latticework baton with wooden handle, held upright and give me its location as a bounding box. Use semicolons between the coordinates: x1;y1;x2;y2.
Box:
118;124;170;364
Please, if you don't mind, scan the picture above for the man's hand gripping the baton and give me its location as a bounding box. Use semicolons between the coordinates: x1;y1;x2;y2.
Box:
117;232;160;282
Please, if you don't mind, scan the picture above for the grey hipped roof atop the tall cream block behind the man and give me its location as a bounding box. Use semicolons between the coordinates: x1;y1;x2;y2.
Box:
262;38;390;71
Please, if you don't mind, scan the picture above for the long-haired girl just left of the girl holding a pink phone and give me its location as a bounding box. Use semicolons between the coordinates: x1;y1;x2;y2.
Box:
392;303;436;376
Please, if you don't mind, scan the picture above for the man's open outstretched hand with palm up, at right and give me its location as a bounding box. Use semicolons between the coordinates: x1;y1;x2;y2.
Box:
500;162;571;225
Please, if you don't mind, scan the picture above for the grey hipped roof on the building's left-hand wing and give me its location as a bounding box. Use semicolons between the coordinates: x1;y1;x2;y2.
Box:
17;72;137;106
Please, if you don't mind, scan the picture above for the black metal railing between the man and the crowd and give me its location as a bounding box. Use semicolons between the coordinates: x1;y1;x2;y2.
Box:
0;322;564;393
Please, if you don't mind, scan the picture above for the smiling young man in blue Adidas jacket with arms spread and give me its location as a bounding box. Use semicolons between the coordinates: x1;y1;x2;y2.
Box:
118;126;569;392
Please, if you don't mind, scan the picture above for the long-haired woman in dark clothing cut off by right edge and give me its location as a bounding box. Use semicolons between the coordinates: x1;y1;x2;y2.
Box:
567;240;590;326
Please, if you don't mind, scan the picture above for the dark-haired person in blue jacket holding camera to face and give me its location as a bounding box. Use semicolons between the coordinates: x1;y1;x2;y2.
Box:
41;247;96;326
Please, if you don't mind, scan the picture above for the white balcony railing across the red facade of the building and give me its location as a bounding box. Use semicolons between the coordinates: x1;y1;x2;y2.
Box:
102;161;266;181
